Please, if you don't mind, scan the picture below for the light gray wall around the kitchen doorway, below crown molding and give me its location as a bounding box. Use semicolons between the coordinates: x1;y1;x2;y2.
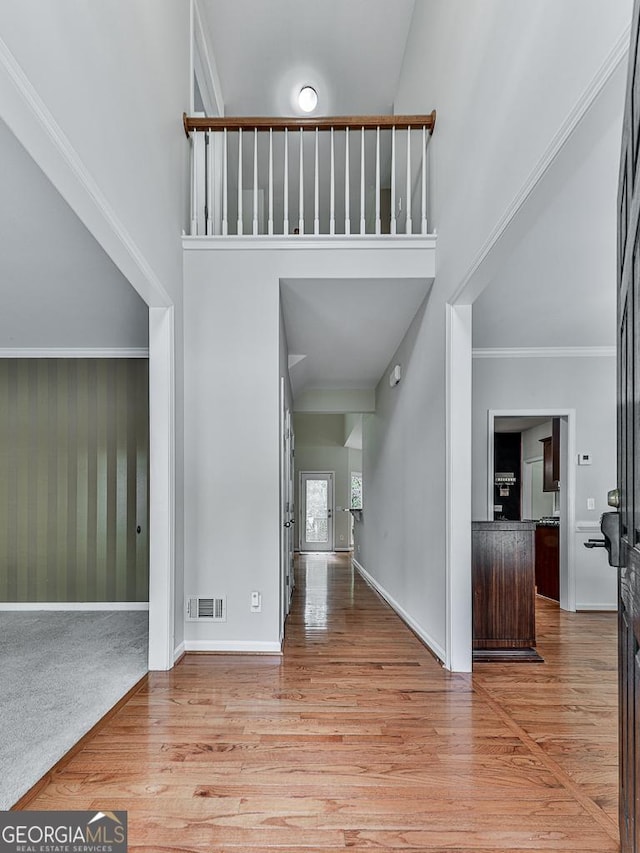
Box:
472;357;617;610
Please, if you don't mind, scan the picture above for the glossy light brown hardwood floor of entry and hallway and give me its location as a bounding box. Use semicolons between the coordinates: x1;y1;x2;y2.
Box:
22;555;618;853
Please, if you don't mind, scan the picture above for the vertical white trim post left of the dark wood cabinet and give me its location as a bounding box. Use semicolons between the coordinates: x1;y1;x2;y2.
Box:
444;305;473;672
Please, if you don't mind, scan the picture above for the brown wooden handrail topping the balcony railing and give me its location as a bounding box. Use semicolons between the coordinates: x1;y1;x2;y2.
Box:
182;110;436;136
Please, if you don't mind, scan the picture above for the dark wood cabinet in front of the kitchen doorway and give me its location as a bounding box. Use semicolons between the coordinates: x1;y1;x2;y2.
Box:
472;521;541;661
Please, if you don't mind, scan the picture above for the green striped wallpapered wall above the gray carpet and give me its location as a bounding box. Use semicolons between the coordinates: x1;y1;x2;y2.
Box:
0;358;149;602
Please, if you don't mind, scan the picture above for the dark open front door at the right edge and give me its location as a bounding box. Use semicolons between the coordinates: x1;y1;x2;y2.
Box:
618;6;640;853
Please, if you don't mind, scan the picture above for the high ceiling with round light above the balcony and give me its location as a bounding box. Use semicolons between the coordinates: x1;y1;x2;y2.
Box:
201;0;415;116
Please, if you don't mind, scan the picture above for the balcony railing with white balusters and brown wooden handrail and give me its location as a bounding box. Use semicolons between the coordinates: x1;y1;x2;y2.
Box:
183;110;436;237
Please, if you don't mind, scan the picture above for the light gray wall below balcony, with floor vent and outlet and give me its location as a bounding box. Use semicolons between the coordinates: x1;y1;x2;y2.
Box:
183;237;435;649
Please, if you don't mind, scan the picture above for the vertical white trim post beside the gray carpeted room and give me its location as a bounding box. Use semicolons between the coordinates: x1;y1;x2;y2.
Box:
149;308;175;670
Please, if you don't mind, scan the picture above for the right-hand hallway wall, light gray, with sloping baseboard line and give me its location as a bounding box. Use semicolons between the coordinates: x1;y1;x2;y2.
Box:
355;294;446;659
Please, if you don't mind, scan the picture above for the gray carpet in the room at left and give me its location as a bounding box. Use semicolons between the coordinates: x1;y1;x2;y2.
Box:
0;611;149;809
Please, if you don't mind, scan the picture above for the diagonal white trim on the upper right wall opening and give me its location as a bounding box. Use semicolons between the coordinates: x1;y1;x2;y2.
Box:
450;26;631;303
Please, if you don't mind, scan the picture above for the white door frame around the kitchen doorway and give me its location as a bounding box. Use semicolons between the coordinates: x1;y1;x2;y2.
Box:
486;408;577;611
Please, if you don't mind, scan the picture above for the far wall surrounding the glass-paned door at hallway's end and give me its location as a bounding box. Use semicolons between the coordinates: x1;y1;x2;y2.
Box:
294;414;351;550
